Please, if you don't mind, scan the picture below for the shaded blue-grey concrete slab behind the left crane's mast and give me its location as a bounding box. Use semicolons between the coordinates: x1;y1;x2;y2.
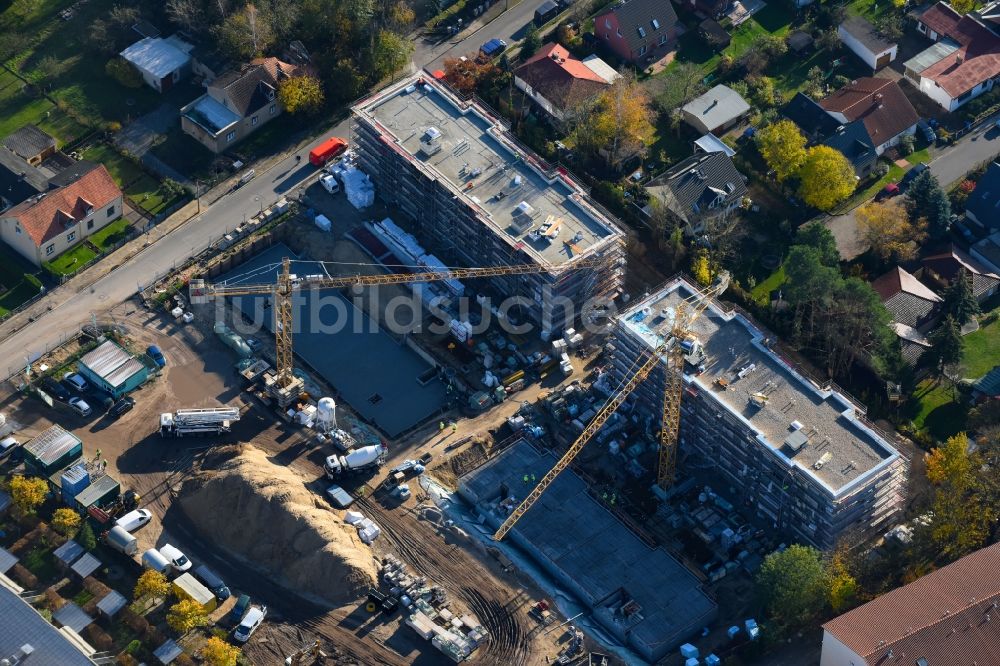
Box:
215;243;447;437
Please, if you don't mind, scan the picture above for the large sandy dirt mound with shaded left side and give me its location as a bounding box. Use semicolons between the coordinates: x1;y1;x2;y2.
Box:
180;446;376;605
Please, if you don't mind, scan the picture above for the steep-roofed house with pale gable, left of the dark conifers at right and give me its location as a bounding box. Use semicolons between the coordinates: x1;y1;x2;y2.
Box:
872;266;944;363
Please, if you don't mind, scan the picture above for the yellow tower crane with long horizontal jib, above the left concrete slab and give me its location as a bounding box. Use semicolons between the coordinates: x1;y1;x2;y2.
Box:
189;257;600;397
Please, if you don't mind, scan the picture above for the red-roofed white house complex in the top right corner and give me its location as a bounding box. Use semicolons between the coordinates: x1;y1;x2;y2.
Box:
904;2;1000;111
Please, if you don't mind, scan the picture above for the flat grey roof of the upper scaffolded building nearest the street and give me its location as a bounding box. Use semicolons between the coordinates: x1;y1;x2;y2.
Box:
353;76;621;266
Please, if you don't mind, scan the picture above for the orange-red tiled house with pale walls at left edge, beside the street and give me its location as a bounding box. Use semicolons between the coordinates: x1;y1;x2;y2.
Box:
0;165;122;266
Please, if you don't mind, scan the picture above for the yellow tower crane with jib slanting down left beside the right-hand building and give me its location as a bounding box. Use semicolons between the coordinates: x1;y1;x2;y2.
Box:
493;274;729;541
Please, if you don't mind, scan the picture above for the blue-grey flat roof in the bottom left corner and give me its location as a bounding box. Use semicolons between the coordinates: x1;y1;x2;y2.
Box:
0;579;95;666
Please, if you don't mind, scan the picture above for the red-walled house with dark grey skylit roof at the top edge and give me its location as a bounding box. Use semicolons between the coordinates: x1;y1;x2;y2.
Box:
594;0;677;63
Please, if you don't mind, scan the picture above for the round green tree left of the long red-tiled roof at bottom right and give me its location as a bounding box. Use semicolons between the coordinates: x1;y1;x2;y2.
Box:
757;544;827;627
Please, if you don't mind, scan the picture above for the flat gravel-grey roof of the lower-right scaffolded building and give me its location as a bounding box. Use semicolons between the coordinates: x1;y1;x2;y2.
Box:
619;279;899;495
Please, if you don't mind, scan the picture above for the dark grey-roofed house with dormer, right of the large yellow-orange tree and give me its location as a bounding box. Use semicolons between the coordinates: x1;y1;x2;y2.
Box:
646;151;747;234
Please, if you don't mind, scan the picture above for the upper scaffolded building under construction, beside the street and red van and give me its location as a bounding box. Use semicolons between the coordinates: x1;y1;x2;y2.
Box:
353;76;625;336
